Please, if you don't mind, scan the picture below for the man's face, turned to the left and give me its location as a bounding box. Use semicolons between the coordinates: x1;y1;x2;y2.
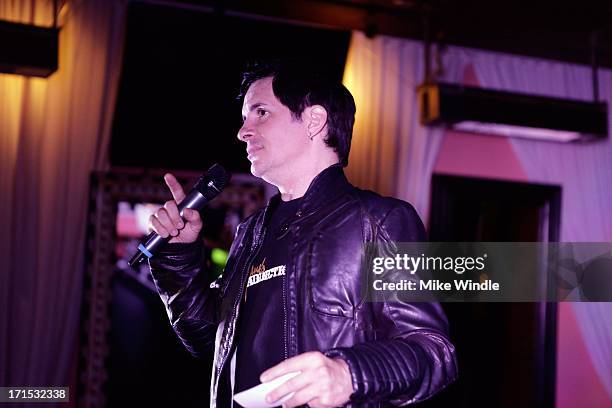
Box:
238;77;309;181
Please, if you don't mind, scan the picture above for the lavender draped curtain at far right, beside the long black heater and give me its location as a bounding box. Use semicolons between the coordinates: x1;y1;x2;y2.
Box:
472;52;612;400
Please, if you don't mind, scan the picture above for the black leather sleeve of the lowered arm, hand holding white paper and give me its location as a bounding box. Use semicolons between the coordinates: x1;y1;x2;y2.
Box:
325;200;457;406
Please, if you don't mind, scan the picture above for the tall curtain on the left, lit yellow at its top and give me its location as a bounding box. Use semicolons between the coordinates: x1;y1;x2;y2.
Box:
0;0;127;394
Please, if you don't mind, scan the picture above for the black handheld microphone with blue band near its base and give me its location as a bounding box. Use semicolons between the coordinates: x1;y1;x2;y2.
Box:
128;163;231;268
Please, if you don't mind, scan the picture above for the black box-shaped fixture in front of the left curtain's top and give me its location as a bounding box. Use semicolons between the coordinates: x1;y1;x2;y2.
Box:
0;21;59;78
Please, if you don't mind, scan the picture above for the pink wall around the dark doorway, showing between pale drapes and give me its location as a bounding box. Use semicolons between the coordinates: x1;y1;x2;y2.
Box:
434;63;612;408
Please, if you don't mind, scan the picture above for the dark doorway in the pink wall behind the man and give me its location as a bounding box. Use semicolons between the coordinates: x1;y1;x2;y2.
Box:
422;175;561;408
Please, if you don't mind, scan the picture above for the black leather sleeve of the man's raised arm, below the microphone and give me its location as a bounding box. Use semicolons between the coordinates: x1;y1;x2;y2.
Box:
149;241;220;357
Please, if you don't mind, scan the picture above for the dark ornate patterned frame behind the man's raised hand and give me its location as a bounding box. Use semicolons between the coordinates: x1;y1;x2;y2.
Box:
77;169;266;408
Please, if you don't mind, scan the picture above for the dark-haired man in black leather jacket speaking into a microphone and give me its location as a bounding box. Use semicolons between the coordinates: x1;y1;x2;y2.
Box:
150;59;456;407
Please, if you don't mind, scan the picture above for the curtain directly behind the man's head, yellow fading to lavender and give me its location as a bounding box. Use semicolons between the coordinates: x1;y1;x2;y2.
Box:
344;32;464;221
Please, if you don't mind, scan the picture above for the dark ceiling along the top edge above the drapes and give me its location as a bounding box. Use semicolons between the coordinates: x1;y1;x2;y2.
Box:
157;0;612;68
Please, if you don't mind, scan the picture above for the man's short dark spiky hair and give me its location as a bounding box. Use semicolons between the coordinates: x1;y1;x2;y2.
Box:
239;61;355;166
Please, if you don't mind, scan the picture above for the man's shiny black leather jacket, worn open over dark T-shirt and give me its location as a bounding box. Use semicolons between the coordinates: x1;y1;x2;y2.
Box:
151;165;457;406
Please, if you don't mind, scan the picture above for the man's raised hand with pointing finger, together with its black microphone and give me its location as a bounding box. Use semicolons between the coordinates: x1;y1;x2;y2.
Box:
128;164;230;267
